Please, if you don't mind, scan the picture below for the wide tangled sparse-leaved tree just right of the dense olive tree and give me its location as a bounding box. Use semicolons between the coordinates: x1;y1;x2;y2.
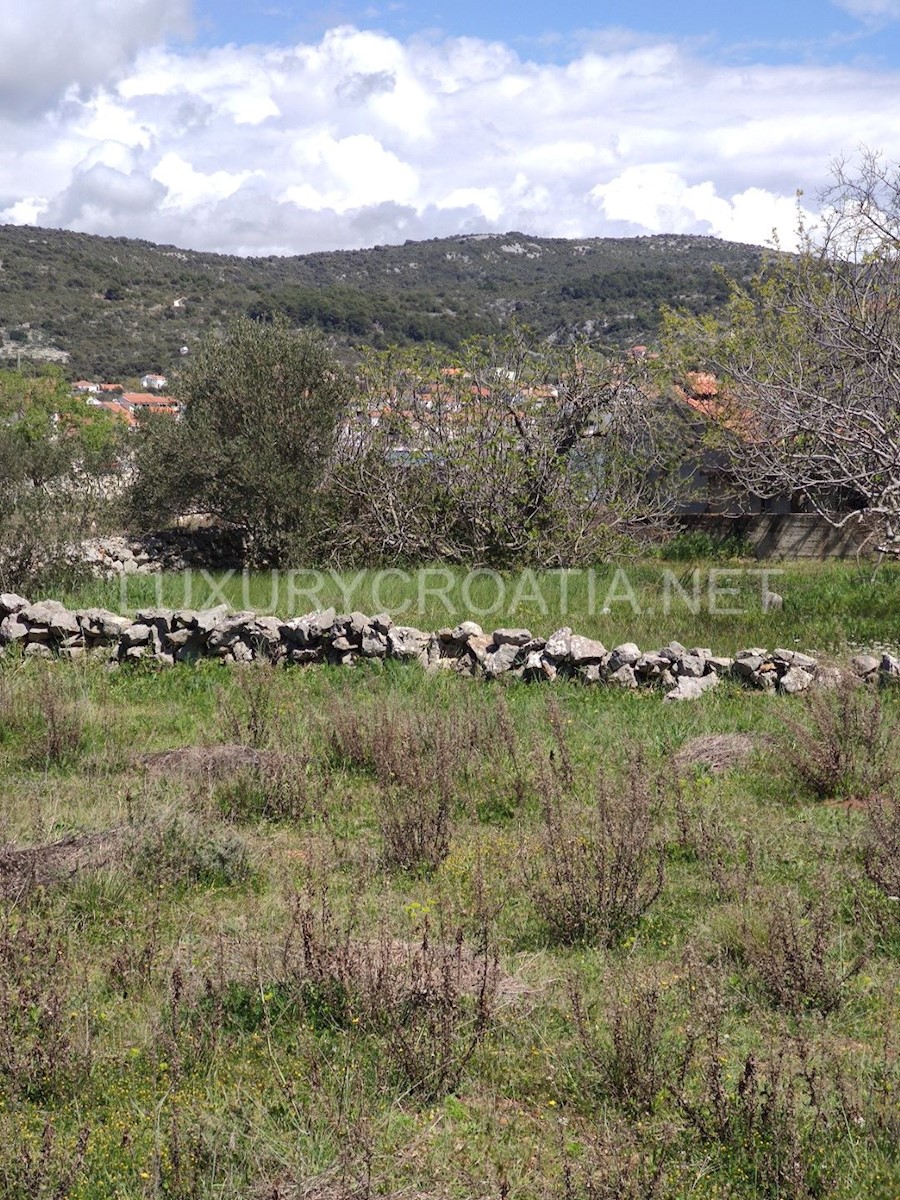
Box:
331;334;674;568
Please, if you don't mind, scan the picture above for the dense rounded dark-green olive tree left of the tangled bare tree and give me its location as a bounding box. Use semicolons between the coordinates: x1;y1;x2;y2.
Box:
131;318;349;566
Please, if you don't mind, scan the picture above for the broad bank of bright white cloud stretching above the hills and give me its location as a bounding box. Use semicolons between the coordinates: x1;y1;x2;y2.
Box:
0;19;900;253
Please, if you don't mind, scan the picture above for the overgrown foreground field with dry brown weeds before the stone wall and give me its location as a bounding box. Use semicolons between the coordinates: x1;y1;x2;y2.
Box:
0;638;900;1200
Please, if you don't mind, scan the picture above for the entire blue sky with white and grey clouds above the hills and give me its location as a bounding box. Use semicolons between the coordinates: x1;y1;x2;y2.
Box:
0;0;900;254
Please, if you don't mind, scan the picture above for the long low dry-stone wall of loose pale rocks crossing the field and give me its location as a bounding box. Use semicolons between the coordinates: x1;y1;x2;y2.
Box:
0;593;900;700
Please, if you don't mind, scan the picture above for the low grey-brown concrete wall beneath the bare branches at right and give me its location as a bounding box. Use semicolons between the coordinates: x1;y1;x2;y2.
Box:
682;512;876;558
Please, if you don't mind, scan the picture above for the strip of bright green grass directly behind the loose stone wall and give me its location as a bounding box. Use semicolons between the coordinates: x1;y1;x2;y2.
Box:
58;559;900;653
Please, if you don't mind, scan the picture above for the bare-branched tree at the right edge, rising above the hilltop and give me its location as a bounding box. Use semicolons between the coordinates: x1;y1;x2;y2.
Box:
666;151;900;554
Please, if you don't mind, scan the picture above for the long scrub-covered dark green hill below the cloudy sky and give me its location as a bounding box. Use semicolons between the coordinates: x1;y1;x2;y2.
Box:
0;226;764;379
